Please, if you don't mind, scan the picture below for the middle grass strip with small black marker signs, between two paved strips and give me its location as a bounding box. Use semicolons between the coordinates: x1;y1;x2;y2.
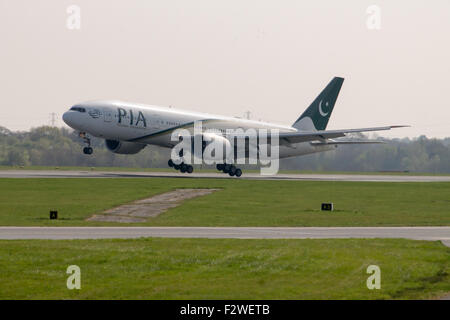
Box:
0;178;450;226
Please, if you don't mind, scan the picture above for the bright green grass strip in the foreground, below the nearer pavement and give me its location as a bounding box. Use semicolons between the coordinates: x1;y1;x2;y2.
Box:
0;238;450;299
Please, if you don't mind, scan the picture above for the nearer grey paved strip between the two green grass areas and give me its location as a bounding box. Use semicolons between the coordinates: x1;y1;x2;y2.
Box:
0;227;450;245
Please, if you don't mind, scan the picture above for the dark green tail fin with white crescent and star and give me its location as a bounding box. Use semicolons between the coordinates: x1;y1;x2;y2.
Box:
292;77;344;130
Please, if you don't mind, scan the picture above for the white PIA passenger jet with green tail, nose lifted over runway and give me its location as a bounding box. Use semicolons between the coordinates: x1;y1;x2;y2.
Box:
62;77;406;177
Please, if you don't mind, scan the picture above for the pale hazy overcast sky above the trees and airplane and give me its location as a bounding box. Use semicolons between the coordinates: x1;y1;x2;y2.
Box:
0;0;450;137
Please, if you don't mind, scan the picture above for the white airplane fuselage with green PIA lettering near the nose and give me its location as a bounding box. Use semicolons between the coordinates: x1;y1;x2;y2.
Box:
63;101;334;158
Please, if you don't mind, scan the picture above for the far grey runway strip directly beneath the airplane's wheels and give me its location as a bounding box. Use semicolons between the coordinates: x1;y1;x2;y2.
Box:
0;170;450;182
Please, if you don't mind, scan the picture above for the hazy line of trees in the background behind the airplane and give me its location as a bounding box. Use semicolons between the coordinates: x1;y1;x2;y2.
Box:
0;126;450;173
